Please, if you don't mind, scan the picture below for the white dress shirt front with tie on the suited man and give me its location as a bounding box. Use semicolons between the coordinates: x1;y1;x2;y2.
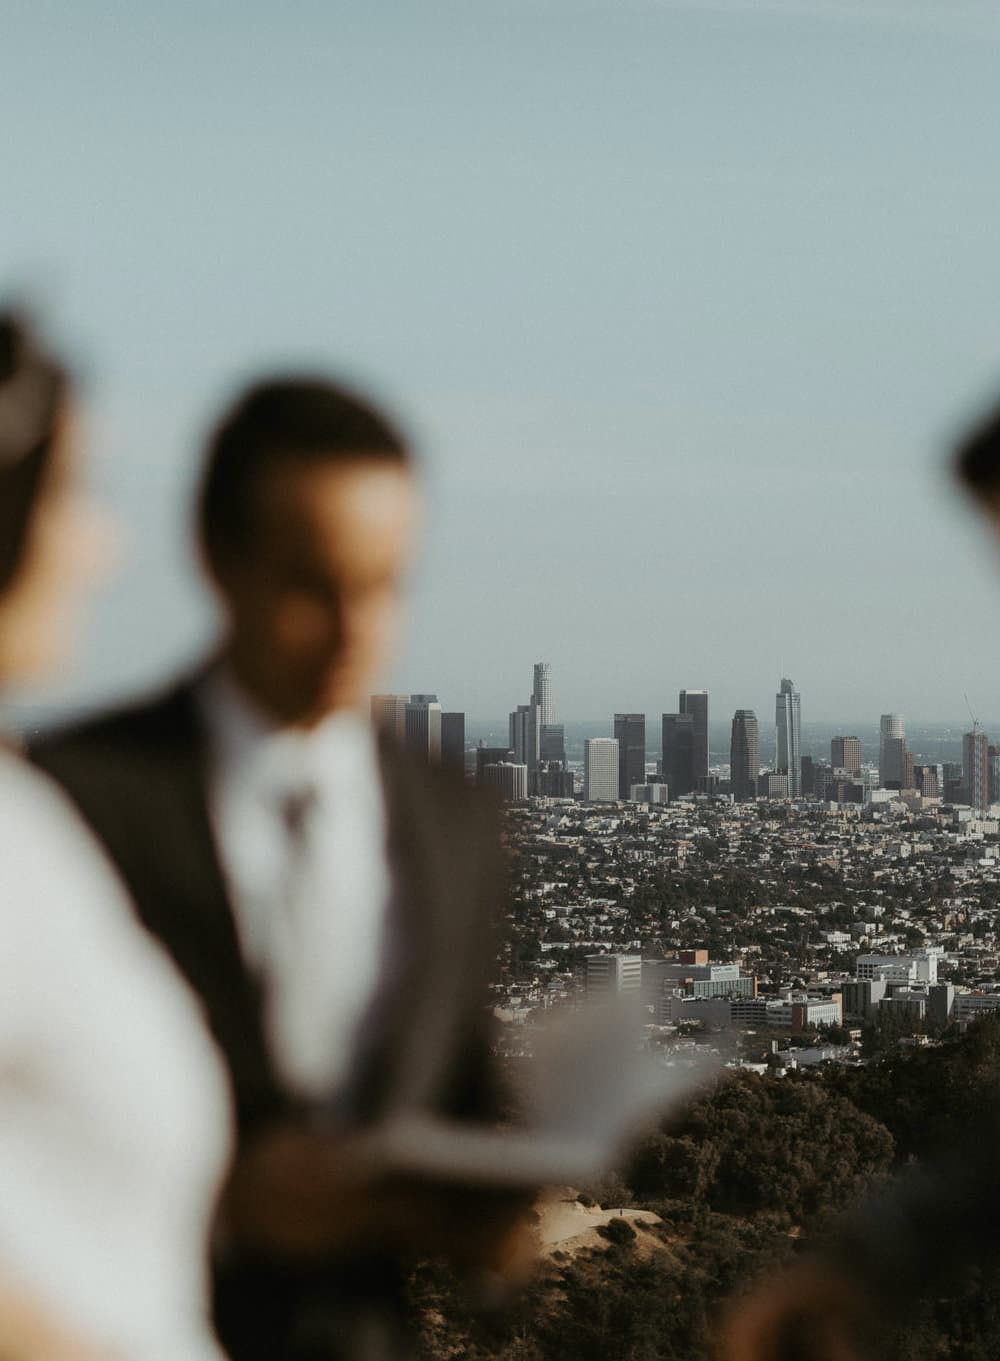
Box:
200;667;390;1098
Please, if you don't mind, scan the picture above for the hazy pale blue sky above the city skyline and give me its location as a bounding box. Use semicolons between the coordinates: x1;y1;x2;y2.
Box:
0;0;1000;721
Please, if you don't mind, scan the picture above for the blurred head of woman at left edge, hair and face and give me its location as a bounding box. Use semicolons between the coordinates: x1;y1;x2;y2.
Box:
0;313;103;681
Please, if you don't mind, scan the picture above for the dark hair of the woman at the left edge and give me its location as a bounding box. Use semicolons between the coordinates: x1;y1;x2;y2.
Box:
0;312;69;592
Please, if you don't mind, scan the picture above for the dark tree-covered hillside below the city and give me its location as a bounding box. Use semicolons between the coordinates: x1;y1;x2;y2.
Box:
412;1022;1000;1361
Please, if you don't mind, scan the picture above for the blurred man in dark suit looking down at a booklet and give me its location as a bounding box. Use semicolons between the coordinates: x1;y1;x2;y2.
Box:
34;378;516;1361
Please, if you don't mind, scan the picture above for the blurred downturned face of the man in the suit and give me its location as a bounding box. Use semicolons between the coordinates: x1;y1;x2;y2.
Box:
214;457;419;725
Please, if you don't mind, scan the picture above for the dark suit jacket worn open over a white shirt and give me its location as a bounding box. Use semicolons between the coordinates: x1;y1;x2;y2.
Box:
33;681;503;1361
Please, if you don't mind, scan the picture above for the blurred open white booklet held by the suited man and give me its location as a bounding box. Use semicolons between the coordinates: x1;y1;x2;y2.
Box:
341;1003;720;1190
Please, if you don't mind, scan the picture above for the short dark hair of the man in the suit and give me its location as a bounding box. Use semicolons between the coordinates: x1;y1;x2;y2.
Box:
197;377;412;557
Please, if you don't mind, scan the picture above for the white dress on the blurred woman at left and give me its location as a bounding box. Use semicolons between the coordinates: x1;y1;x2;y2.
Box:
0;753;230;1361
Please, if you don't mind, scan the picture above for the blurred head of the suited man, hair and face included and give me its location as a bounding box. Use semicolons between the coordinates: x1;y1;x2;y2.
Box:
197;376;419;725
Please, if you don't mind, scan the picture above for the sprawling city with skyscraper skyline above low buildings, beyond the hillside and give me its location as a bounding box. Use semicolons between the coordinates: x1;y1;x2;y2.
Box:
371;663;1000;1071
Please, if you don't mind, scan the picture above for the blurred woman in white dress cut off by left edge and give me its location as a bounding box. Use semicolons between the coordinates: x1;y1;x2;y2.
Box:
0;314;229;1361
